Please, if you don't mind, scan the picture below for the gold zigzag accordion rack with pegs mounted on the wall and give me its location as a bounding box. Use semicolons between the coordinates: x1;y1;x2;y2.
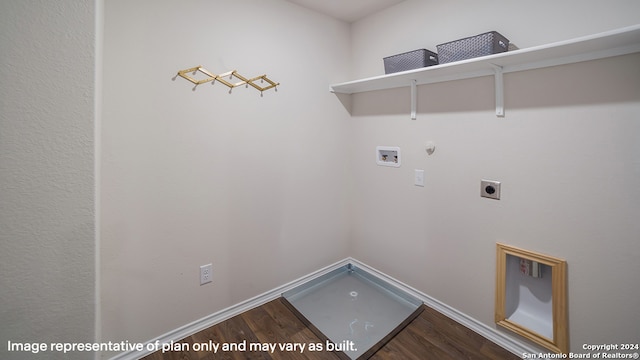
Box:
173;65;280;96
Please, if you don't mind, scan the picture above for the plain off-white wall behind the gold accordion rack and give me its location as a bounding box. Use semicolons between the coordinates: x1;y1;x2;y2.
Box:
100;0;350;352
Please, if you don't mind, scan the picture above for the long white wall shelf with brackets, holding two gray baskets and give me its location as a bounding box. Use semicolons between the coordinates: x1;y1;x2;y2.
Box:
330;24;640;119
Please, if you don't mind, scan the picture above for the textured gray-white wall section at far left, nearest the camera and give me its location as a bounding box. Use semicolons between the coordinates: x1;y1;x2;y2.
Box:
0;0;95;359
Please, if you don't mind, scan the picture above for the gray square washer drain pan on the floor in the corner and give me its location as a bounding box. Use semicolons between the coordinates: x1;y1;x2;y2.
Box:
283;264;422;359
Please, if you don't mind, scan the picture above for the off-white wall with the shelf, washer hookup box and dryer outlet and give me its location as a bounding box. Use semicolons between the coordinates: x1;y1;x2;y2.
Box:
351;0;640;352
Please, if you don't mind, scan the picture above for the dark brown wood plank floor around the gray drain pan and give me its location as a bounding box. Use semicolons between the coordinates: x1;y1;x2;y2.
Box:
144;299;519;360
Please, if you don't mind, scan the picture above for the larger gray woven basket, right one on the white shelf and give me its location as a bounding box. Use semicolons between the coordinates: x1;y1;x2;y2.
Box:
436;31;509;64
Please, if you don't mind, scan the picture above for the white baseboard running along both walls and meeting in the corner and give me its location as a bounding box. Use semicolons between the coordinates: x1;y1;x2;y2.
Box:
110;257;538;360
